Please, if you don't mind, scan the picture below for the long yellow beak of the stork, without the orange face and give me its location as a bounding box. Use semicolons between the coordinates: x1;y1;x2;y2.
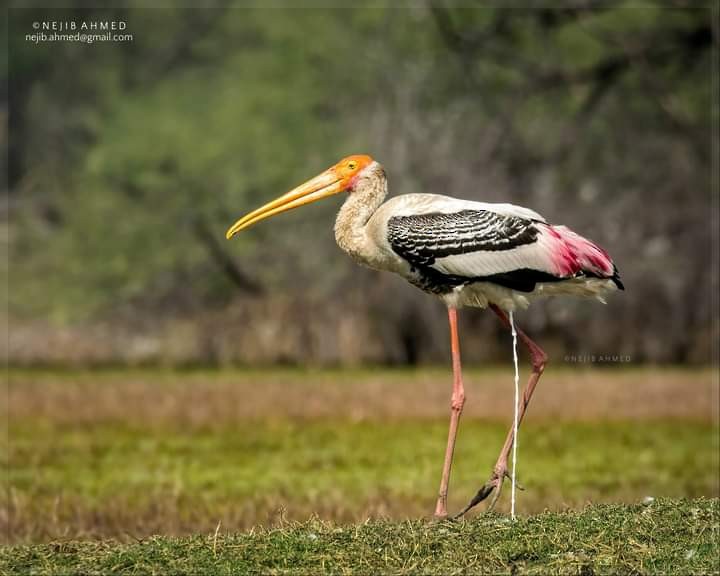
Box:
225;169;345;240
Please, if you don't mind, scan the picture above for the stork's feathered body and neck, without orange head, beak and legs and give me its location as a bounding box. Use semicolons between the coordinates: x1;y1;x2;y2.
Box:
335;162;622;310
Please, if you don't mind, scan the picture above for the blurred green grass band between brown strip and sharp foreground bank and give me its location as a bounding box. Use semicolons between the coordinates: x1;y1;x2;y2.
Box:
8;420;720;541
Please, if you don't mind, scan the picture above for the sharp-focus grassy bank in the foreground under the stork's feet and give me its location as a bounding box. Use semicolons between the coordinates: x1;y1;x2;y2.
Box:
2;499;720;574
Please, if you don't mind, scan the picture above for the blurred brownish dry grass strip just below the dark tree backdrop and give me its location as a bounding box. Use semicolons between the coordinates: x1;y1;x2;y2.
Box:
8;366;719;426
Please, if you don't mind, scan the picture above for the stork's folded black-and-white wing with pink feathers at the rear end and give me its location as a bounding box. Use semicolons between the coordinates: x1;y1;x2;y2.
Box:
387;209;619;292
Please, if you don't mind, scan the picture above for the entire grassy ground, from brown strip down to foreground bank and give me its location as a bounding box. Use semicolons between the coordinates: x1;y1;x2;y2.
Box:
1;368;720;572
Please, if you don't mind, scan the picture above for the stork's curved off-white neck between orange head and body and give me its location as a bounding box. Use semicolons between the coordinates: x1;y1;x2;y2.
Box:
335;162;387;267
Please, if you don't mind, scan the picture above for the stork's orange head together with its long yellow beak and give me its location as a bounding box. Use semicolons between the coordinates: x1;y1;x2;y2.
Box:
225;154;373;240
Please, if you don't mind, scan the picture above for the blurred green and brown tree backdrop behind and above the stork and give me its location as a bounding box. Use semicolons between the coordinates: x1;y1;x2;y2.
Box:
1;0;720;365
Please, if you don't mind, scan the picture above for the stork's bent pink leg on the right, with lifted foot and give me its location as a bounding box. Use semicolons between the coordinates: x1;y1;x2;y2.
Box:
456;304;547;517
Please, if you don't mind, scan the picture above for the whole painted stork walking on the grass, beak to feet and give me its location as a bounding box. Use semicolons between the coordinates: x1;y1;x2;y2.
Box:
226;154;624;519
